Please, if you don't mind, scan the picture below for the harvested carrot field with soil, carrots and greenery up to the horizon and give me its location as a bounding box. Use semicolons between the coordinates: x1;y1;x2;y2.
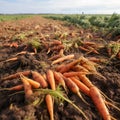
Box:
0;13;120;120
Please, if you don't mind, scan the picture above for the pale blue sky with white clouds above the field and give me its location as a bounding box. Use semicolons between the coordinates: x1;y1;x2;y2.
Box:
0;0;120;14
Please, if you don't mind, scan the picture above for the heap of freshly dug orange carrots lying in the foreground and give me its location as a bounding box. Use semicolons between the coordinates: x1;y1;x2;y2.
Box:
2;55;119;120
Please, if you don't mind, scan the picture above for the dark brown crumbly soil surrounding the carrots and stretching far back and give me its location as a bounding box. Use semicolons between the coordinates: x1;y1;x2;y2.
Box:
0;16;120;120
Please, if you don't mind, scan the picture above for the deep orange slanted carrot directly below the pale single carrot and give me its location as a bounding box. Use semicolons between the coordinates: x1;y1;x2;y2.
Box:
57;59;80;73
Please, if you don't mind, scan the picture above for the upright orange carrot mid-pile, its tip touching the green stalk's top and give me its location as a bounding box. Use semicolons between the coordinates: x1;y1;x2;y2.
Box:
47;69;56;90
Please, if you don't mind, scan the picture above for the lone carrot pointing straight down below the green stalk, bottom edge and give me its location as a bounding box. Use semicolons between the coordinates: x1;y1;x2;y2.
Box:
45;94;54;120
